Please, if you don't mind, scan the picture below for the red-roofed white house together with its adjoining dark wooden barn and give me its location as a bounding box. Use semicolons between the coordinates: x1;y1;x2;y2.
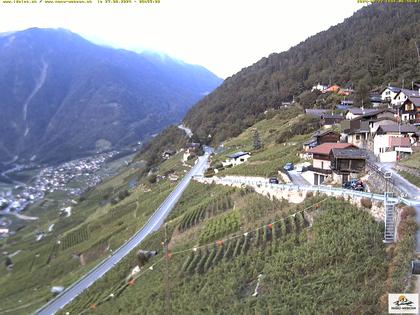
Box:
308;143;366;185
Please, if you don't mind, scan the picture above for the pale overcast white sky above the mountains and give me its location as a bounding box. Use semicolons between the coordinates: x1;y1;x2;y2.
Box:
0;0;363;78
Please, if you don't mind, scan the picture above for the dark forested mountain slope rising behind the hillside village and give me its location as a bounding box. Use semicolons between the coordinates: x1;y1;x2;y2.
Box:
184;4;420;142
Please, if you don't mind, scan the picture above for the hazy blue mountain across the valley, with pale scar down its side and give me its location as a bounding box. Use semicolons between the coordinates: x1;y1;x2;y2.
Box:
0;28;222;162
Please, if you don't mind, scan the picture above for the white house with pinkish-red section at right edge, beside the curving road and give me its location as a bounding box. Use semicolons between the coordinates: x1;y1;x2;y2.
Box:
373;124;418;162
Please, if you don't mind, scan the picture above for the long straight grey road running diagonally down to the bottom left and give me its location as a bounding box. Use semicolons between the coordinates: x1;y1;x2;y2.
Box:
36;149;210;315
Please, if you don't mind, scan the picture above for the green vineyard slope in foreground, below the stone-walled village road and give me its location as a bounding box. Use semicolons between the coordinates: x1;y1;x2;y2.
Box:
61;183;415;314
